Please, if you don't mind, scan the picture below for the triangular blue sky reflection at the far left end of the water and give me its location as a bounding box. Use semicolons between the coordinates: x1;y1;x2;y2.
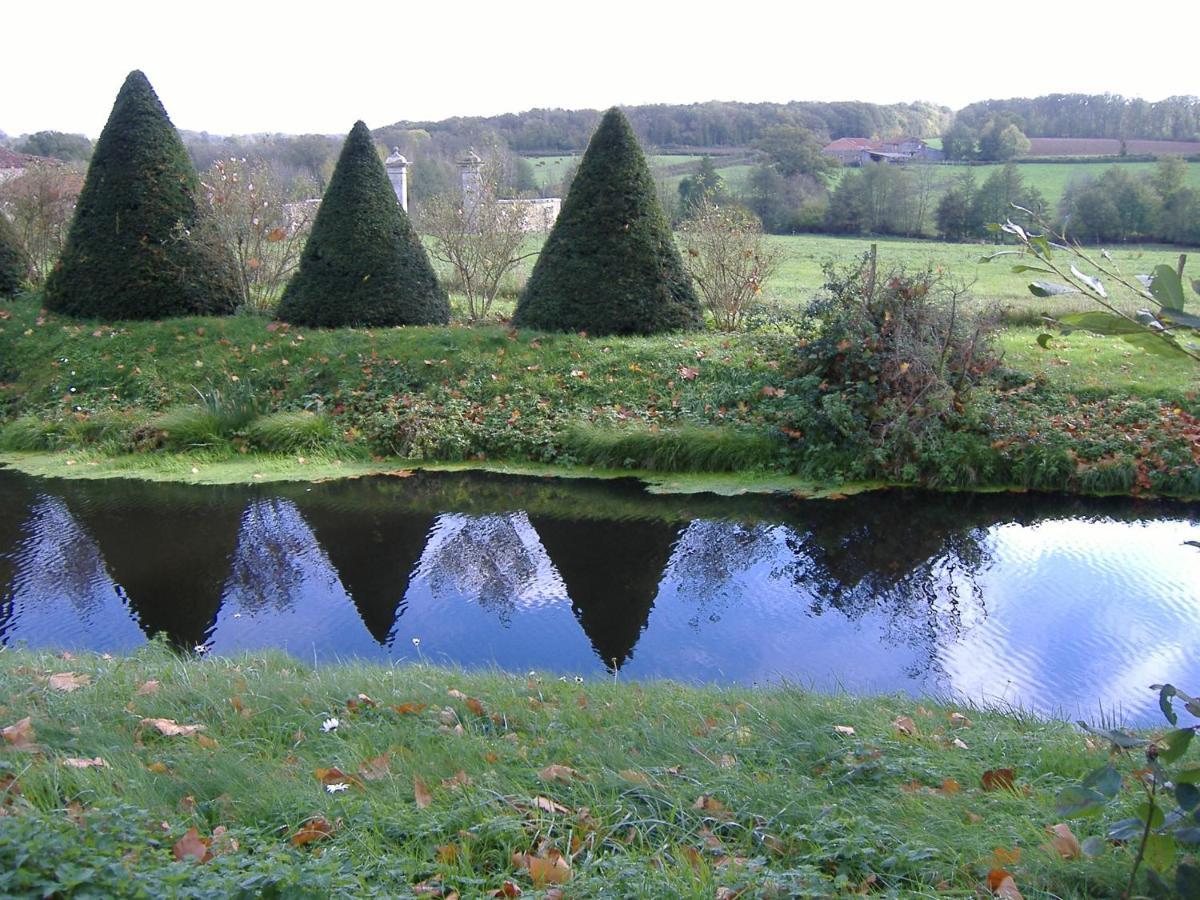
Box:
0;497;145;653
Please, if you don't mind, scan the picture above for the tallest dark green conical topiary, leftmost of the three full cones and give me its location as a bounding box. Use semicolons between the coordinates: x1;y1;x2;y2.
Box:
46;71;238;319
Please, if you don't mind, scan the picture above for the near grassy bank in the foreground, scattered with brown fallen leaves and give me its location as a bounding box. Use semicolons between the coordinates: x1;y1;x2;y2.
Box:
0;644;1156;898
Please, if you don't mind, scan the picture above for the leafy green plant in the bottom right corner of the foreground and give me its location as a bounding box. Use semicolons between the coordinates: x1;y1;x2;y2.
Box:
1056;684;1200;896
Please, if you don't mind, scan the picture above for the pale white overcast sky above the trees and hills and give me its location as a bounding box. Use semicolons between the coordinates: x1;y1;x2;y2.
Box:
9;0;1200;138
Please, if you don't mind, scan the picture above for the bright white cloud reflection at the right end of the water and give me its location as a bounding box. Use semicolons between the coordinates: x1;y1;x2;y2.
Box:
942;520;1200;721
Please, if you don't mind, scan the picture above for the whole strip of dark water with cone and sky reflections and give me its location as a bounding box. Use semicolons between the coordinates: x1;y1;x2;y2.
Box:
0;470;1200;725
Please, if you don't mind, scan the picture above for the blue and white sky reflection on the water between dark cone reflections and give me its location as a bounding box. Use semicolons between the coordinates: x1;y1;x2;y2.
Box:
0;472;1200;724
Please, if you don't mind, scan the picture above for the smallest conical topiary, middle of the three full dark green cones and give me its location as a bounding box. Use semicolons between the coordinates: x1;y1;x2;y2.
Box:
276;122;450;326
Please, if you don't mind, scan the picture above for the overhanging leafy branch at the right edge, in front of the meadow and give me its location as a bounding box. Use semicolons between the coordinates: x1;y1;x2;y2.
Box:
980;206;1200;362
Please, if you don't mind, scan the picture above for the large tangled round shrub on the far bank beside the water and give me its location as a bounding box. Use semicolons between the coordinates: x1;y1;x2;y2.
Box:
787;254;998;478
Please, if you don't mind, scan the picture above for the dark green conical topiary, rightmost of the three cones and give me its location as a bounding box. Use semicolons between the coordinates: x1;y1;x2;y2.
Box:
512;107;701;335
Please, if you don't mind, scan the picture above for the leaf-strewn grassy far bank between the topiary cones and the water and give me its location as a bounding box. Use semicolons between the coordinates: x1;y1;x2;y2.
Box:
0;289;1200;497
